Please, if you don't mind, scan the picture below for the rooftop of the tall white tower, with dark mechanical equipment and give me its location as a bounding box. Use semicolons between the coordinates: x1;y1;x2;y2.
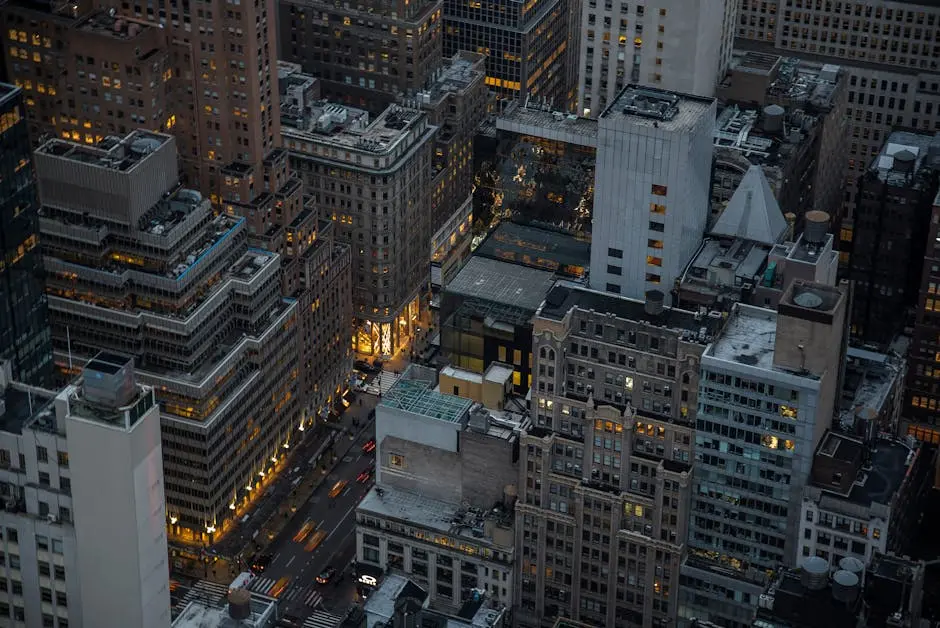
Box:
600;85;715;131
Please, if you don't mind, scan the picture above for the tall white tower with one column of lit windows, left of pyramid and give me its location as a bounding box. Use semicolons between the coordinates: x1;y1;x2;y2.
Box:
590;85;716;300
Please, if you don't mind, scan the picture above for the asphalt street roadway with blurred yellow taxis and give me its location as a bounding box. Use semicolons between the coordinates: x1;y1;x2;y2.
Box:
249;418;375;617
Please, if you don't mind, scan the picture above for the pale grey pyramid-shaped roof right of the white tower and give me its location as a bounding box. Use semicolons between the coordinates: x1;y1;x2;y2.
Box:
712;166;787;244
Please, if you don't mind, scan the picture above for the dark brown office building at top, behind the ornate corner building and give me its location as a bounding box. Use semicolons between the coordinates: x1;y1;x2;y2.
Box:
271;0;444;115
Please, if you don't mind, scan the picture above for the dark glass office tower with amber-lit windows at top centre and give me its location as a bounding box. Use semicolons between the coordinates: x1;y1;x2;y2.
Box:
443;0;573;106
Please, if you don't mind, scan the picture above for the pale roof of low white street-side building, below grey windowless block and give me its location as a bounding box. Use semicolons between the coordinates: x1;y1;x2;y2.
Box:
357;486;513;544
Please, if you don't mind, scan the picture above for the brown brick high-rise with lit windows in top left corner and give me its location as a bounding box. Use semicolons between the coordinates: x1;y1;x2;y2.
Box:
2;0;280;206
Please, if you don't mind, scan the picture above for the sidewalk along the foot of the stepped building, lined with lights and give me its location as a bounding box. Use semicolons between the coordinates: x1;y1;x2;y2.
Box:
178;393;379;584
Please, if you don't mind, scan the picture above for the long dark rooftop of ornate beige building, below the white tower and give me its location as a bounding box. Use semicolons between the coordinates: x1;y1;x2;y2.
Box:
539;281;722;344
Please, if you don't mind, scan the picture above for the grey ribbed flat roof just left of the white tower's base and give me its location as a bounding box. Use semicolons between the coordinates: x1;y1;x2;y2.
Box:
445;255;555;312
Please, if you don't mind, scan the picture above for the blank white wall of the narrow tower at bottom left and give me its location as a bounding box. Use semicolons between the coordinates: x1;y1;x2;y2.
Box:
67;392;170;628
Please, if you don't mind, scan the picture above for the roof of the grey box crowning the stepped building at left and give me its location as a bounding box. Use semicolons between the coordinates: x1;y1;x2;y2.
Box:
36;130;173;172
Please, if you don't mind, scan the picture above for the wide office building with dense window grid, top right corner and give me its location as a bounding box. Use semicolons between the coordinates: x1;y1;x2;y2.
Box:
736;0;940;233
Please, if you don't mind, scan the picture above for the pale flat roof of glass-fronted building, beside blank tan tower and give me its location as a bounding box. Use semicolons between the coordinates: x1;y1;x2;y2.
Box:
707;306;777;371
